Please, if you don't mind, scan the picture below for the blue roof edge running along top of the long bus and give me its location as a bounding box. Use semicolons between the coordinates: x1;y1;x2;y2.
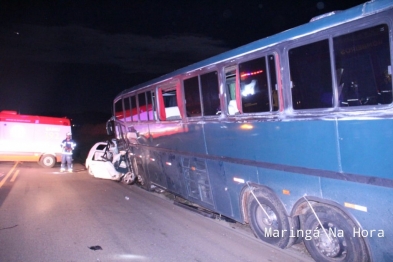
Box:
115;0;393;99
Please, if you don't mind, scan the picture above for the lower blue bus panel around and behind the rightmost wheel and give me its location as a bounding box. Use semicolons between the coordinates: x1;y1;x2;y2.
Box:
321;178;393;261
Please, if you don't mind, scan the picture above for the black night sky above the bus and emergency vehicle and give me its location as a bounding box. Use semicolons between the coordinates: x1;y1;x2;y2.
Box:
0;0;364;123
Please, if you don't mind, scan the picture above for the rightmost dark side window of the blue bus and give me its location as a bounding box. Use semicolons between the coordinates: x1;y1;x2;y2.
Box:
333;25;392;107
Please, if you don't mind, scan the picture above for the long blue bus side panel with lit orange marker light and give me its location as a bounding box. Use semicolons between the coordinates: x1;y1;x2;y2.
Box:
205;120;339;174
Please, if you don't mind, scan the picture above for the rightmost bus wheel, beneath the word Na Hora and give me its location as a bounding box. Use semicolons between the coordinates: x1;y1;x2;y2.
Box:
303;204;370;262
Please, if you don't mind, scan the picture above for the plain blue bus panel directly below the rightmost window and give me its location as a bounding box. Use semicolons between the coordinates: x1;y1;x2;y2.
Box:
339;119;393;179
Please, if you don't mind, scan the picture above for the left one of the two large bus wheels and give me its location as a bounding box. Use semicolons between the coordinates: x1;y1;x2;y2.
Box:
248;191;293;248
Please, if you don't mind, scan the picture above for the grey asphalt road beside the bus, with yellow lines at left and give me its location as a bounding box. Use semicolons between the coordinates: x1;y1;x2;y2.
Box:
0;162;312;262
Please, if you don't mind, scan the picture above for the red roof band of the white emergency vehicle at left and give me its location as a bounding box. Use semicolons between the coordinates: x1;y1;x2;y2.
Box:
0;110;71;126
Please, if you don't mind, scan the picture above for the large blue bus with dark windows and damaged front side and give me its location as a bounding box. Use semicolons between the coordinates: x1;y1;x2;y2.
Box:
107;0;393;261
